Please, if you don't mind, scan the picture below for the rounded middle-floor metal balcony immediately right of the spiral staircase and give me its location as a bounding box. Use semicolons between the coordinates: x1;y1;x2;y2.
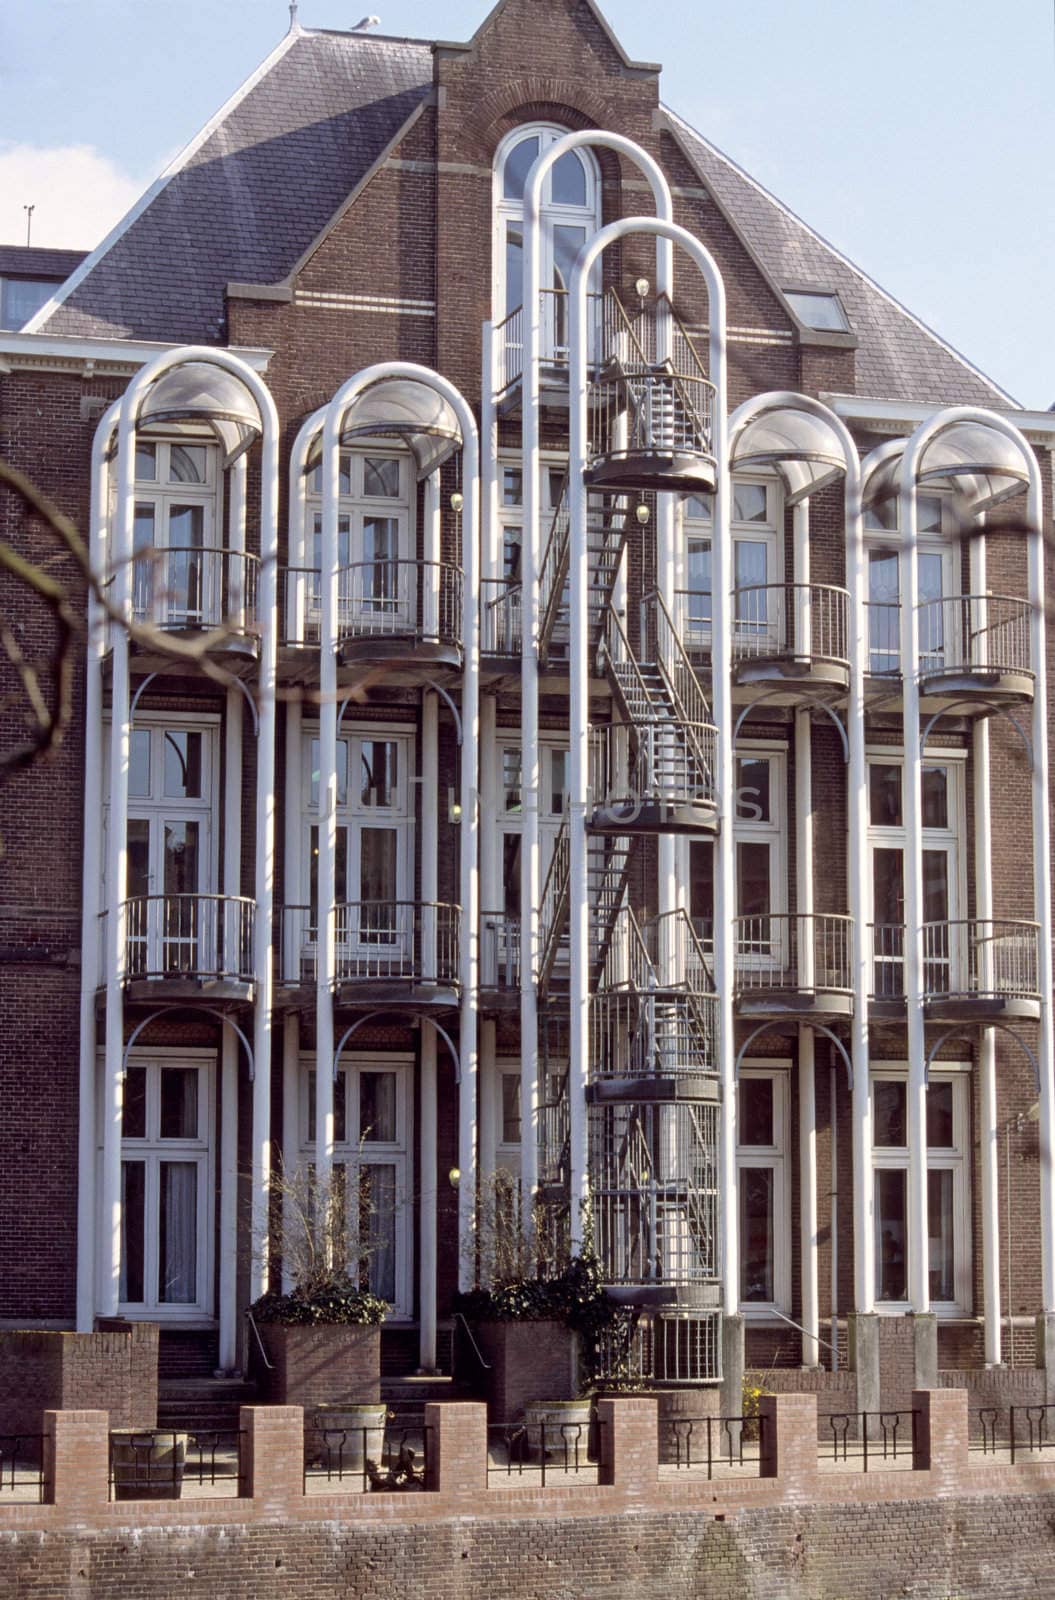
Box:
733;912;853;1019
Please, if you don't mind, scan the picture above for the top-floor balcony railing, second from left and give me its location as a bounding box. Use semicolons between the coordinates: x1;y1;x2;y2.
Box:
282;560;461;645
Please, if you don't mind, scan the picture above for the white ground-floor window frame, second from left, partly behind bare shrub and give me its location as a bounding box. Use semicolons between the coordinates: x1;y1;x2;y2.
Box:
298;1050;415;1322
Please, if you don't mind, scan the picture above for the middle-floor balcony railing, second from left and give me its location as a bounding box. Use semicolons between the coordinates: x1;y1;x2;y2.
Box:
275;901;461;987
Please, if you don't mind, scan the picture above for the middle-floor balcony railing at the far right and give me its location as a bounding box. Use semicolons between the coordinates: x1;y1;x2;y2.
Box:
871;918;1041;1002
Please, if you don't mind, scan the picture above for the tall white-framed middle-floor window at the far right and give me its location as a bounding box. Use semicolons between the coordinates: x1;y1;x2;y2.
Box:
868;750;965;998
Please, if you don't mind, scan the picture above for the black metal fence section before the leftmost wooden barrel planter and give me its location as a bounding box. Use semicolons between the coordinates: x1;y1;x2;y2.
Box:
109;1429;247;1499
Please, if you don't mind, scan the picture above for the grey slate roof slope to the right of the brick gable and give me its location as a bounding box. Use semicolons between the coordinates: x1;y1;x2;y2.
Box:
663;107;1018;410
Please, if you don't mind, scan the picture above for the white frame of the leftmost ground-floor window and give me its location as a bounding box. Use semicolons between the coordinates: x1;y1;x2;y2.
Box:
112;1046;216;1325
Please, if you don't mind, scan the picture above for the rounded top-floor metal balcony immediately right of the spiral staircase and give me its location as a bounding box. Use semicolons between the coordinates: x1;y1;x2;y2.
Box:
730;584;850;704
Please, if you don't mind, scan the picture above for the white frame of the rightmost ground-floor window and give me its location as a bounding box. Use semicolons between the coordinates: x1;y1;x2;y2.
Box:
868;1061;973;1317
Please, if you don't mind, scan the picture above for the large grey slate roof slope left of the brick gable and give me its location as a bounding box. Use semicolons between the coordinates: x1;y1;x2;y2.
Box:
29;29;432;342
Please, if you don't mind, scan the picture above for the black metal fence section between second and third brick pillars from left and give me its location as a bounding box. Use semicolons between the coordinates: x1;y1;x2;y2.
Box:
304;1413;432;1494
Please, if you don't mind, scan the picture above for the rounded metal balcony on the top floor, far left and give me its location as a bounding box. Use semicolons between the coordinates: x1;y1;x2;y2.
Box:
131;546;261;672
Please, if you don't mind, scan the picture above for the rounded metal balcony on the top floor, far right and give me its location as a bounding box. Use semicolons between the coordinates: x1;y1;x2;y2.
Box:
917;595;1034;707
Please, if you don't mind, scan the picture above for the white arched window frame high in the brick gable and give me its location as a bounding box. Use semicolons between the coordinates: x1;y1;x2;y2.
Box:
491;122;602;362
